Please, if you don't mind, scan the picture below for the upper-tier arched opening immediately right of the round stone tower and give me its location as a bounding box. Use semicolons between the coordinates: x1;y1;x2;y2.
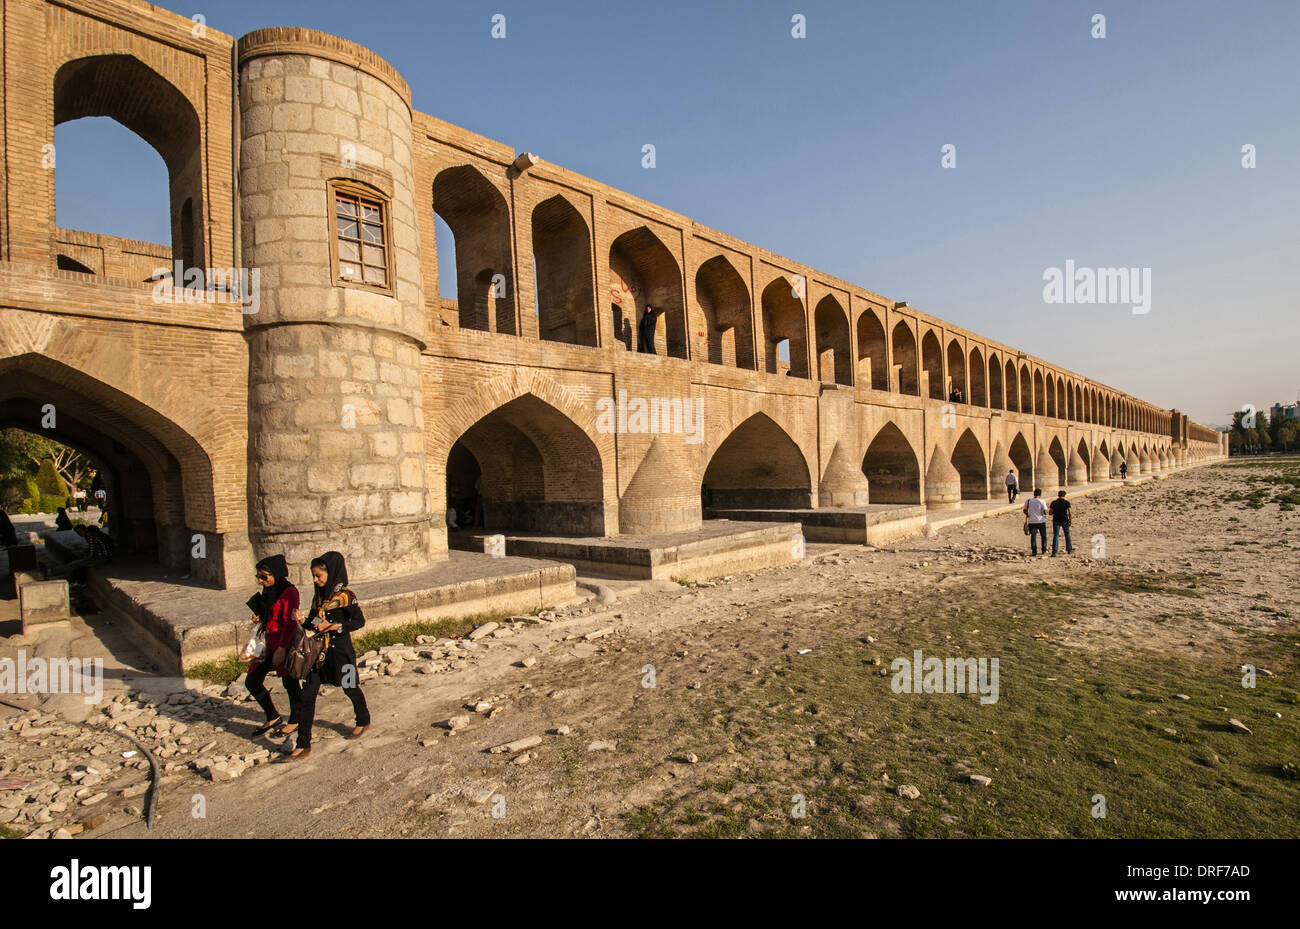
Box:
433;165;516;335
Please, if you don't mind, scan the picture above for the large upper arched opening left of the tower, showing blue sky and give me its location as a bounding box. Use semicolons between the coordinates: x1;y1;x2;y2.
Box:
53;55;207;274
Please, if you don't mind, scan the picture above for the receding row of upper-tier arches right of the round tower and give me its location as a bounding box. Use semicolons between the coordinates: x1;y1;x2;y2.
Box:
433;165;1170;434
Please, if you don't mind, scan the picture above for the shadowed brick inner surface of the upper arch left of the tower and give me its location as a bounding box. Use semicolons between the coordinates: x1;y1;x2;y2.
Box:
51;53;209;268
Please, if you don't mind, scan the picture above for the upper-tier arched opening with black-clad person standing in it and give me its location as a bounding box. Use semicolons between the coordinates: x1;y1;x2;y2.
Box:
610;226;686;359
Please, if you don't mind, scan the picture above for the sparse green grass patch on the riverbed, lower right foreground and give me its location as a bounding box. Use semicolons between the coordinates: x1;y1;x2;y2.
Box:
624;584;1300;838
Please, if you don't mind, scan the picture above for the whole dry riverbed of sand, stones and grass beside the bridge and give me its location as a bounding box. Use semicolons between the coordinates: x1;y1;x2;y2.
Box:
0;460;1300;838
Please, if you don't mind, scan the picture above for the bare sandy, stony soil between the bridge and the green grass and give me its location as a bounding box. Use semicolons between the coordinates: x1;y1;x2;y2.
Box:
0;463;1300;838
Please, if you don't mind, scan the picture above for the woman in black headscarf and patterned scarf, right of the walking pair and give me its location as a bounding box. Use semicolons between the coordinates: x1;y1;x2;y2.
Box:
285;552;371;761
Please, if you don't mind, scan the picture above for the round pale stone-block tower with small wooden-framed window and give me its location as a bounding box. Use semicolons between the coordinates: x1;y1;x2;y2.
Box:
238;27;443;582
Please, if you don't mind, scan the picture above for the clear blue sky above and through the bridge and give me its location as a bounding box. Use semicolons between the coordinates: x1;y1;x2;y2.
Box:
57;0;1300;425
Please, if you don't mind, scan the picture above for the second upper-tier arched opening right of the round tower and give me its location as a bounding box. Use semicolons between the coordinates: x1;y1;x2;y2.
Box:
533;194;595;346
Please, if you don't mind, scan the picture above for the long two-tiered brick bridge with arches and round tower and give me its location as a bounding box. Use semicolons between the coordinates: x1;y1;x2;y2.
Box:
0;0;1225;587
